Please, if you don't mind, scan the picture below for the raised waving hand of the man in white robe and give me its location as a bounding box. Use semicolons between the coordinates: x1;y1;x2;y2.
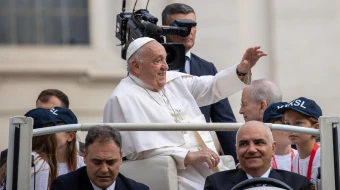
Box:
237;46;267;73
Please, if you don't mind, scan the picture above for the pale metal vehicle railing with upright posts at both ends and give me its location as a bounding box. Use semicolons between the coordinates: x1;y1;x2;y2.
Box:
6;117;340;190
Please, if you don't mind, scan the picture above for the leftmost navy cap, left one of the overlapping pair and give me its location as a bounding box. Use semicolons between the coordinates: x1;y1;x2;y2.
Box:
25;108;57;129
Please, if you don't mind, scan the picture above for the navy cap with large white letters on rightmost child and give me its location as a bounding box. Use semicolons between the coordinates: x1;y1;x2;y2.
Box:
278;97;322;119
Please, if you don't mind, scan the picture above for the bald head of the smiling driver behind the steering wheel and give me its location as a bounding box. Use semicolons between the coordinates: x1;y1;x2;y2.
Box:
236;121;276;173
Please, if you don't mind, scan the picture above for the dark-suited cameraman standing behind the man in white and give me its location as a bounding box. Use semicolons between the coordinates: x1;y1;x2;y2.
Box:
162;3;237;161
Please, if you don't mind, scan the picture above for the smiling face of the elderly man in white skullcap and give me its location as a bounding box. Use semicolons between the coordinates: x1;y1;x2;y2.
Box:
133;41;169;90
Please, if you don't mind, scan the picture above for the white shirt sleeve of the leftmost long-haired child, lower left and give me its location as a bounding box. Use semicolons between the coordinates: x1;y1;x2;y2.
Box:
31;160;50;190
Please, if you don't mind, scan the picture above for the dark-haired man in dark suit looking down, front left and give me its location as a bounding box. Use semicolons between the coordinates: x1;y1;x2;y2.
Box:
51;126;149;190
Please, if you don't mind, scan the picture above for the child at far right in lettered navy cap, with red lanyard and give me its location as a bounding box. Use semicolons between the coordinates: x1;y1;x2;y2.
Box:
278;97;322;190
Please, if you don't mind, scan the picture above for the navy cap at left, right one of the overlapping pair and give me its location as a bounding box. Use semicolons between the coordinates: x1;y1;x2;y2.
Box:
49;107;78;124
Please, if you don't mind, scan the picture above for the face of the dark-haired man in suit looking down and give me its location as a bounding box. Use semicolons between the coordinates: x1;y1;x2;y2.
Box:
84;140;122;188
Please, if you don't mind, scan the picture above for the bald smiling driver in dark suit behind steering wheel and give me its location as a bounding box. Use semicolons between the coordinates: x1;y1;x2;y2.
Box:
204;121;312;190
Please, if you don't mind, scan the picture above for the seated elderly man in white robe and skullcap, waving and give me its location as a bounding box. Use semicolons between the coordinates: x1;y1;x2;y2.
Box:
103;37;266;189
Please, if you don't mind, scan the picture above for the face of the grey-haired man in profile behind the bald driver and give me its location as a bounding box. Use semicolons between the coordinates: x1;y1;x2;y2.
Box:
239;88;266;122
